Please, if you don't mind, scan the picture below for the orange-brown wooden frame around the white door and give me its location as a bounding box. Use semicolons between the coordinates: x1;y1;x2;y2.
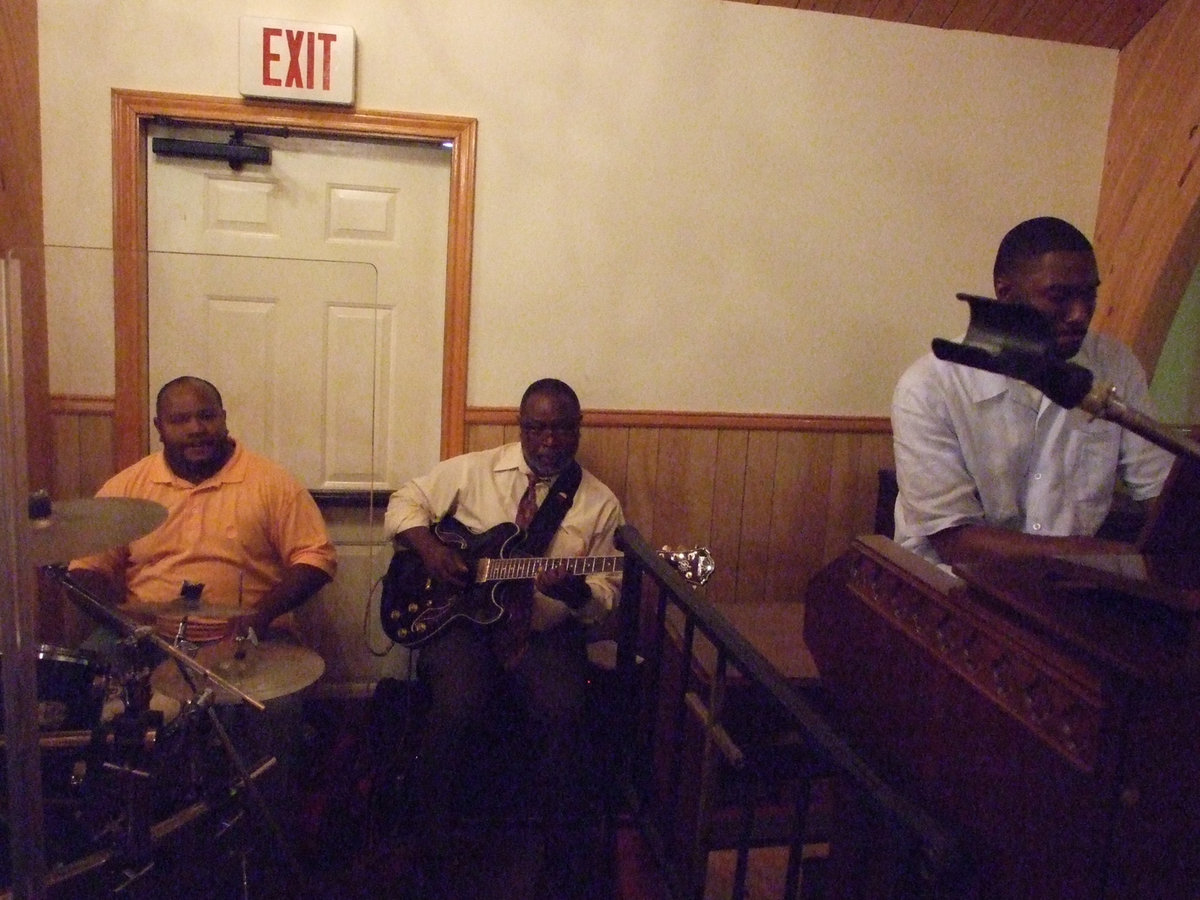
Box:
112;89;479;469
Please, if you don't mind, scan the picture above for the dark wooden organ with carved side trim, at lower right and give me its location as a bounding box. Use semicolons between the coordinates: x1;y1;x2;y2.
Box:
804;529;1200;900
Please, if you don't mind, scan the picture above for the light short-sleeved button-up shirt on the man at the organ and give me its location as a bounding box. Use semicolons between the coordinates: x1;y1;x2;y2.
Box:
892;332;1174;563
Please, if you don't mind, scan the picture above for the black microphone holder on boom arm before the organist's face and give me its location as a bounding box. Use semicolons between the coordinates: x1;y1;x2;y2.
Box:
932;294;1200;461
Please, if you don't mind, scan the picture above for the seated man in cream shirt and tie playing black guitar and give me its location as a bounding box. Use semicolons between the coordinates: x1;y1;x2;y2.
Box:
385;378;624;898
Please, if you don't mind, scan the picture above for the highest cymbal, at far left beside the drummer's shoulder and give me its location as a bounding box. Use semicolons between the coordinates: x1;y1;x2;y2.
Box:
29;497;167;565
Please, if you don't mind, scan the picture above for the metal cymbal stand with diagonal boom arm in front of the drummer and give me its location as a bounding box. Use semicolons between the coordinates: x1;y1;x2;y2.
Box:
46;565;302;896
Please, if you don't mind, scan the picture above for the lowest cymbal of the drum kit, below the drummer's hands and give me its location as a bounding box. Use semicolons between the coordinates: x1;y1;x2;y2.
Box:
150;641;325;703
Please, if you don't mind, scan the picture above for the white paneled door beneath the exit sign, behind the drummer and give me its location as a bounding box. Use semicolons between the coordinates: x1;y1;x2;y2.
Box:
148;127;450;690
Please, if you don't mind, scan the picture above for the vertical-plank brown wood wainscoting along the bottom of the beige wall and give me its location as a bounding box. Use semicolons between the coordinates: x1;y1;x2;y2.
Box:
52;397;893;619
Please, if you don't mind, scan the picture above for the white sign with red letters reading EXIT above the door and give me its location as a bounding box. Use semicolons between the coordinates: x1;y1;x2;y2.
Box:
238;17;354;103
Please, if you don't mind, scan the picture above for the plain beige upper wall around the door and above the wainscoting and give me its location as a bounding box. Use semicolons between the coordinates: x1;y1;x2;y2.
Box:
38;0;1117;415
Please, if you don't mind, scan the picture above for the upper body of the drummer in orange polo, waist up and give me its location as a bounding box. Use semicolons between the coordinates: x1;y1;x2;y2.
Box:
71;376;337;642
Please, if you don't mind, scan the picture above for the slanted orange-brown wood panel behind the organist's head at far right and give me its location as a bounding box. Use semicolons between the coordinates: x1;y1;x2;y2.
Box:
1096;0;1200;372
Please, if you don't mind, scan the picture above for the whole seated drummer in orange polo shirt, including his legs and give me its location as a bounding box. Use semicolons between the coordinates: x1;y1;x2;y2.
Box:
70;376;337;868
